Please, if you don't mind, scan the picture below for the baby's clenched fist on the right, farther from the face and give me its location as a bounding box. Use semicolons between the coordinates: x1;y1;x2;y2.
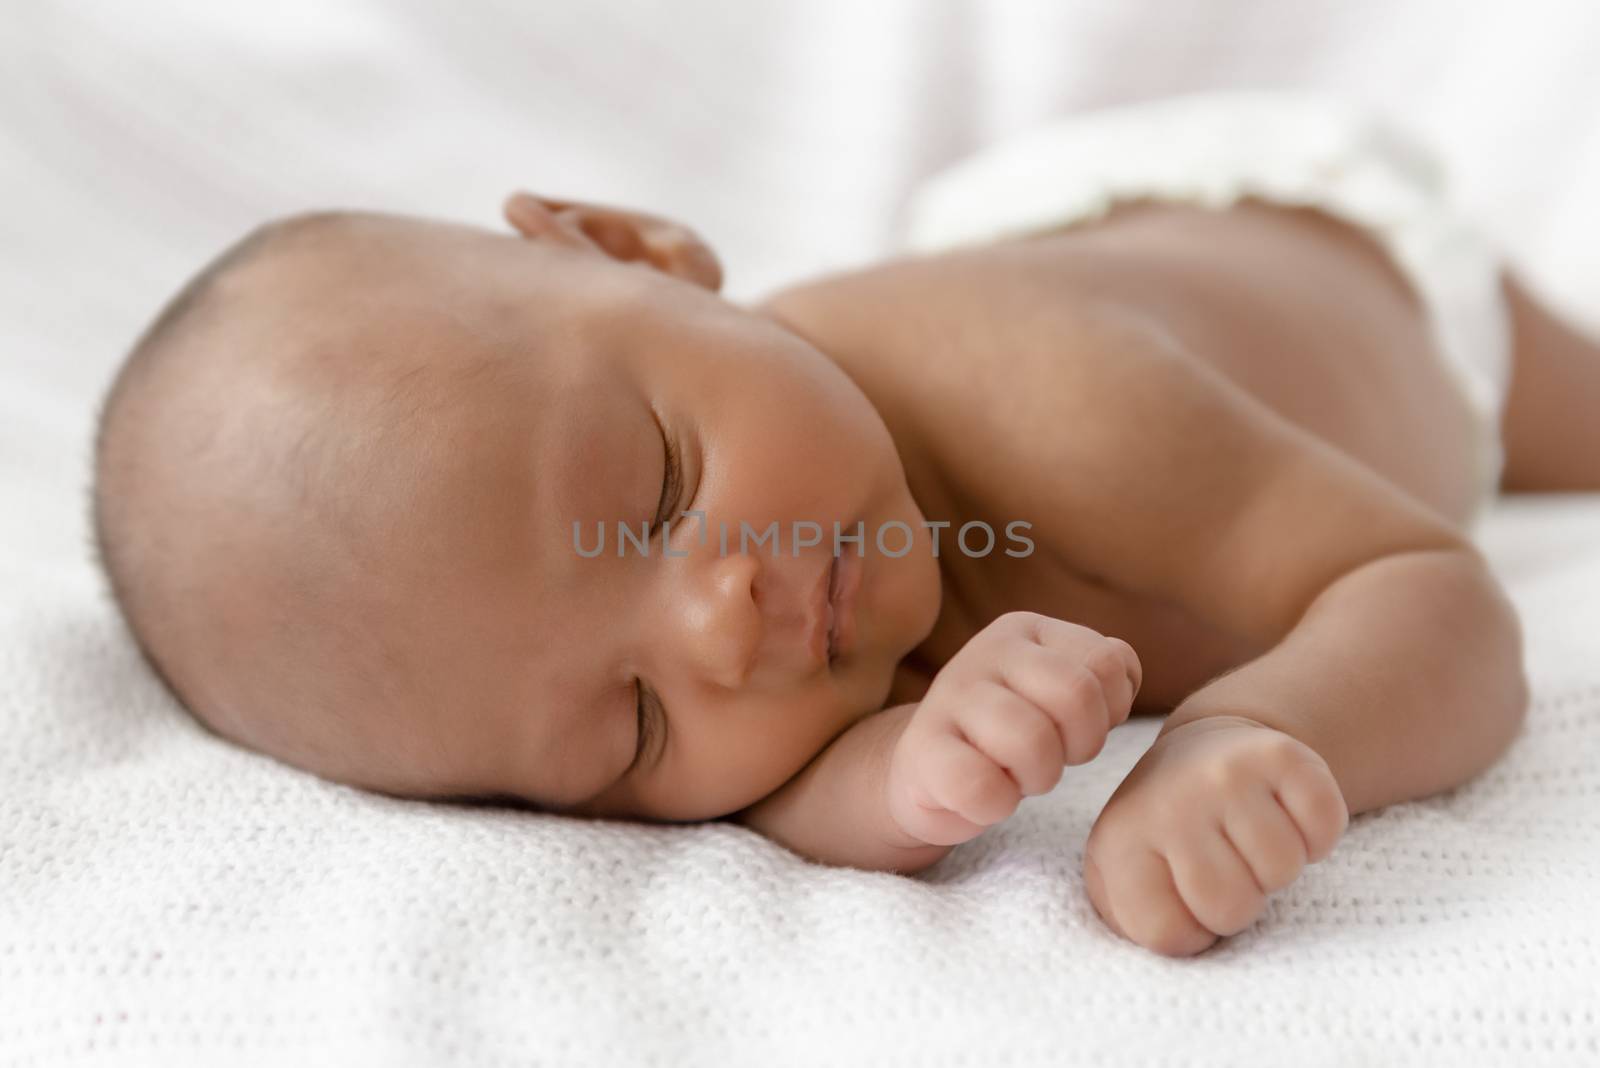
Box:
1083;716;1350;956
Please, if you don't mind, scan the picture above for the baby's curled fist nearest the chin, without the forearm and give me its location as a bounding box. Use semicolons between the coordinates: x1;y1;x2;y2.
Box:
888;612;1144;846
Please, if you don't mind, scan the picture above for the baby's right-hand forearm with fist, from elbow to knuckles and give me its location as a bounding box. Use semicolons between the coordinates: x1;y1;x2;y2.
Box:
1083;548;1526;956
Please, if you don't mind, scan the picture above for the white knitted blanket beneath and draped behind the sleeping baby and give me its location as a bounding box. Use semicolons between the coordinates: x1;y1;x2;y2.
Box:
0;0;1600;1068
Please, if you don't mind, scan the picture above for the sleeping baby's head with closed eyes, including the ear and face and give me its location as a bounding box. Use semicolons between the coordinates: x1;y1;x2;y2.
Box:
94;195;939;820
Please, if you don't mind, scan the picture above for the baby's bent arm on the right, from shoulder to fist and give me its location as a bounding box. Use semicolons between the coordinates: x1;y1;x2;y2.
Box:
1040;306;1528;954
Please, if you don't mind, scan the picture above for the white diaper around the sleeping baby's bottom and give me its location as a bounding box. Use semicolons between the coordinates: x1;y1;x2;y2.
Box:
906;91;1512;529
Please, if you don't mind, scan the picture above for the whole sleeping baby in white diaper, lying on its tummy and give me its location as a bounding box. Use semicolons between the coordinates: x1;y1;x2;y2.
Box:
94;94;1600;954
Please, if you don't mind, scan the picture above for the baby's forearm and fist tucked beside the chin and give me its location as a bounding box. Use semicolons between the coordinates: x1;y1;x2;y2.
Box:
731;612;1142;873
